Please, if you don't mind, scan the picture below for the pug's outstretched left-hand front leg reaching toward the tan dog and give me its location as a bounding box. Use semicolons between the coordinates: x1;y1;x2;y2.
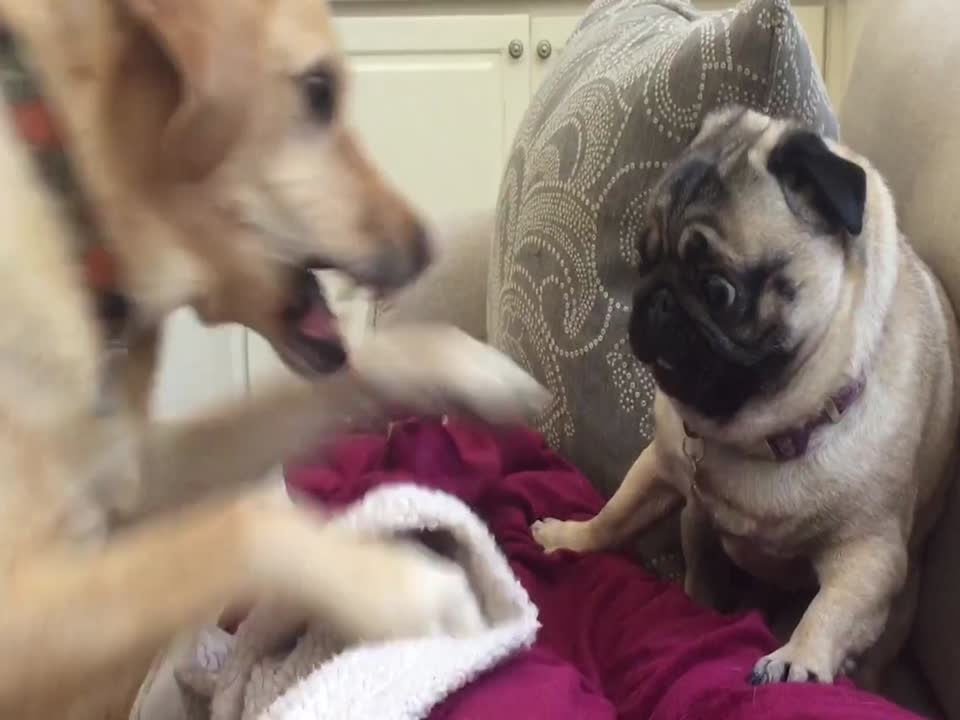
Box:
531;443;680;552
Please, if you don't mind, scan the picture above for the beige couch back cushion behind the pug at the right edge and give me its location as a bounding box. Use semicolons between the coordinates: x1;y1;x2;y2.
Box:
843;0;960;718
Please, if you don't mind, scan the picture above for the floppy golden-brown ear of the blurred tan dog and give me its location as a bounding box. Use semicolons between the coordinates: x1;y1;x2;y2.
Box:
118;0;262;182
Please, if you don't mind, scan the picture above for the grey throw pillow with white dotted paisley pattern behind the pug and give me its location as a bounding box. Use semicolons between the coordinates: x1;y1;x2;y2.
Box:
487;0;837;569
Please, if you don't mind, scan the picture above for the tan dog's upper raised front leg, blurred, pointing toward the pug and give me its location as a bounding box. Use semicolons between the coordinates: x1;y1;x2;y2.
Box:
123;326;549;521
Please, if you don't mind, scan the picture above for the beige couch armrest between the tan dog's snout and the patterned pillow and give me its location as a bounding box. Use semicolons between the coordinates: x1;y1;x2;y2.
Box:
374;210;495;340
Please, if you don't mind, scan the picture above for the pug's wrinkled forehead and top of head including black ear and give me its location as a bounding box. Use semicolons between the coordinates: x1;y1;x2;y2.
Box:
638;107;866;272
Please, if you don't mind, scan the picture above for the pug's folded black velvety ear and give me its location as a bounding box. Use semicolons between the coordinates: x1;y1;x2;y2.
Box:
767;130;867;235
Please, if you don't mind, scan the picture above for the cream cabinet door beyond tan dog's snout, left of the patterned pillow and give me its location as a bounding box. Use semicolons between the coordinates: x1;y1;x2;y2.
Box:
249;14;533;386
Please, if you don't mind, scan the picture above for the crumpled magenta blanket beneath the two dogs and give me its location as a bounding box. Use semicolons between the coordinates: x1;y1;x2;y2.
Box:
287;421;915;720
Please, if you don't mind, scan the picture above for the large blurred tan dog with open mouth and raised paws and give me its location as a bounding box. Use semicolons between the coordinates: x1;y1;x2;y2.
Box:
0;0;544;720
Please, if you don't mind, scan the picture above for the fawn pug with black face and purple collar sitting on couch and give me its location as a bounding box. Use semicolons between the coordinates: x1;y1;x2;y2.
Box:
533;109;958;683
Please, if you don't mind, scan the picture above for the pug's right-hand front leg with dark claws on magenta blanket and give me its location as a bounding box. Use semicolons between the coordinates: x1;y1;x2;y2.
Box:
750;532;907;684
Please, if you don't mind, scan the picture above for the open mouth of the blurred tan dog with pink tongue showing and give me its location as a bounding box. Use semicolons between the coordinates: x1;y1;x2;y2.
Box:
277;263;347;375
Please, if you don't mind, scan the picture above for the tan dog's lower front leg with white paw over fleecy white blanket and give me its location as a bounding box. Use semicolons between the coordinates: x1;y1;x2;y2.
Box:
0;498;483;720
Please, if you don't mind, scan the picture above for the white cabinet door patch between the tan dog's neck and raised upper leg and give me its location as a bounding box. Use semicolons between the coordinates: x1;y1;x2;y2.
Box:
153;310;247;418
